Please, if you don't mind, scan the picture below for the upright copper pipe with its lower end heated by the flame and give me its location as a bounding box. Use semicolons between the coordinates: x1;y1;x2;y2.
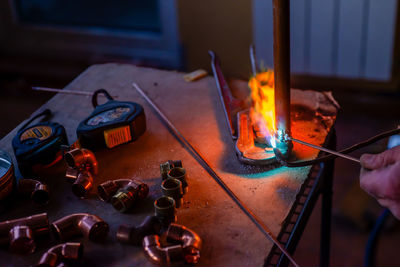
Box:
272;0;292;157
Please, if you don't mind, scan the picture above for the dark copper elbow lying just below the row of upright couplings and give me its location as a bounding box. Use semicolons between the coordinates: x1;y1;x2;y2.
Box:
117;216;161;246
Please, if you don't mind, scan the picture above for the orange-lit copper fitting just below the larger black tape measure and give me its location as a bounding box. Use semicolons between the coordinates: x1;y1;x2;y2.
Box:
64;148;99;197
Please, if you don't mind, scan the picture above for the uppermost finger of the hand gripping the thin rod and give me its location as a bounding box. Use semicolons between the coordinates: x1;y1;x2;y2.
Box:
360;146;400;170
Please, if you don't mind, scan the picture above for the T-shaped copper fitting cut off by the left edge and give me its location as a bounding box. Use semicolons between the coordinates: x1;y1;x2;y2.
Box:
0;213;49;254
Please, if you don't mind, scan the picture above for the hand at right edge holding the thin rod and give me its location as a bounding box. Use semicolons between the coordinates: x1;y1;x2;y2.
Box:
360;146;400;220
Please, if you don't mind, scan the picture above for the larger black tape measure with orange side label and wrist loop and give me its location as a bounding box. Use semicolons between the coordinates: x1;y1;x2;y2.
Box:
76;89;146;150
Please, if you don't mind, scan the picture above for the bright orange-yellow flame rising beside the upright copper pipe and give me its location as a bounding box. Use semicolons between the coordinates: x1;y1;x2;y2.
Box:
248;70;276;147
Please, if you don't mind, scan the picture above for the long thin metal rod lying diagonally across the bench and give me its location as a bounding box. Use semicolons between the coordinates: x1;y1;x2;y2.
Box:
132;83;299;267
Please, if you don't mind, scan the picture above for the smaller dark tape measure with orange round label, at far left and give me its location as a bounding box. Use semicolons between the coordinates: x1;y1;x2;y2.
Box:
12;109;68;176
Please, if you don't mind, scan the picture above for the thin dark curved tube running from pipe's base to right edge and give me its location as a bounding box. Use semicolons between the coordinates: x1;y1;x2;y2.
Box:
274;128;400;167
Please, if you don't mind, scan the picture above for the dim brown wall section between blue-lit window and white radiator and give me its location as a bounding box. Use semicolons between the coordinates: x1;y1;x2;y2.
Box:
177;0;253;78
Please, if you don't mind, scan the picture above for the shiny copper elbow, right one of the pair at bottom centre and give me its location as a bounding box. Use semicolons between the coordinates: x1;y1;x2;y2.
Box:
166;223;202;264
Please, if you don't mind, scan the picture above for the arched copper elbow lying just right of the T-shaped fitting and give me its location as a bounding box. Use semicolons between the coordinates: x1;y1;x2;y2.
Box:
52;213;109;242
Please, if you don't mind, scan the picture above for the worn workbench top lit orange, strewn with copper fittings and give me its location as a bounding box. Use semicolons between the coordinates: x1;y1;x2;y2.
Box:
0;64;336;266
